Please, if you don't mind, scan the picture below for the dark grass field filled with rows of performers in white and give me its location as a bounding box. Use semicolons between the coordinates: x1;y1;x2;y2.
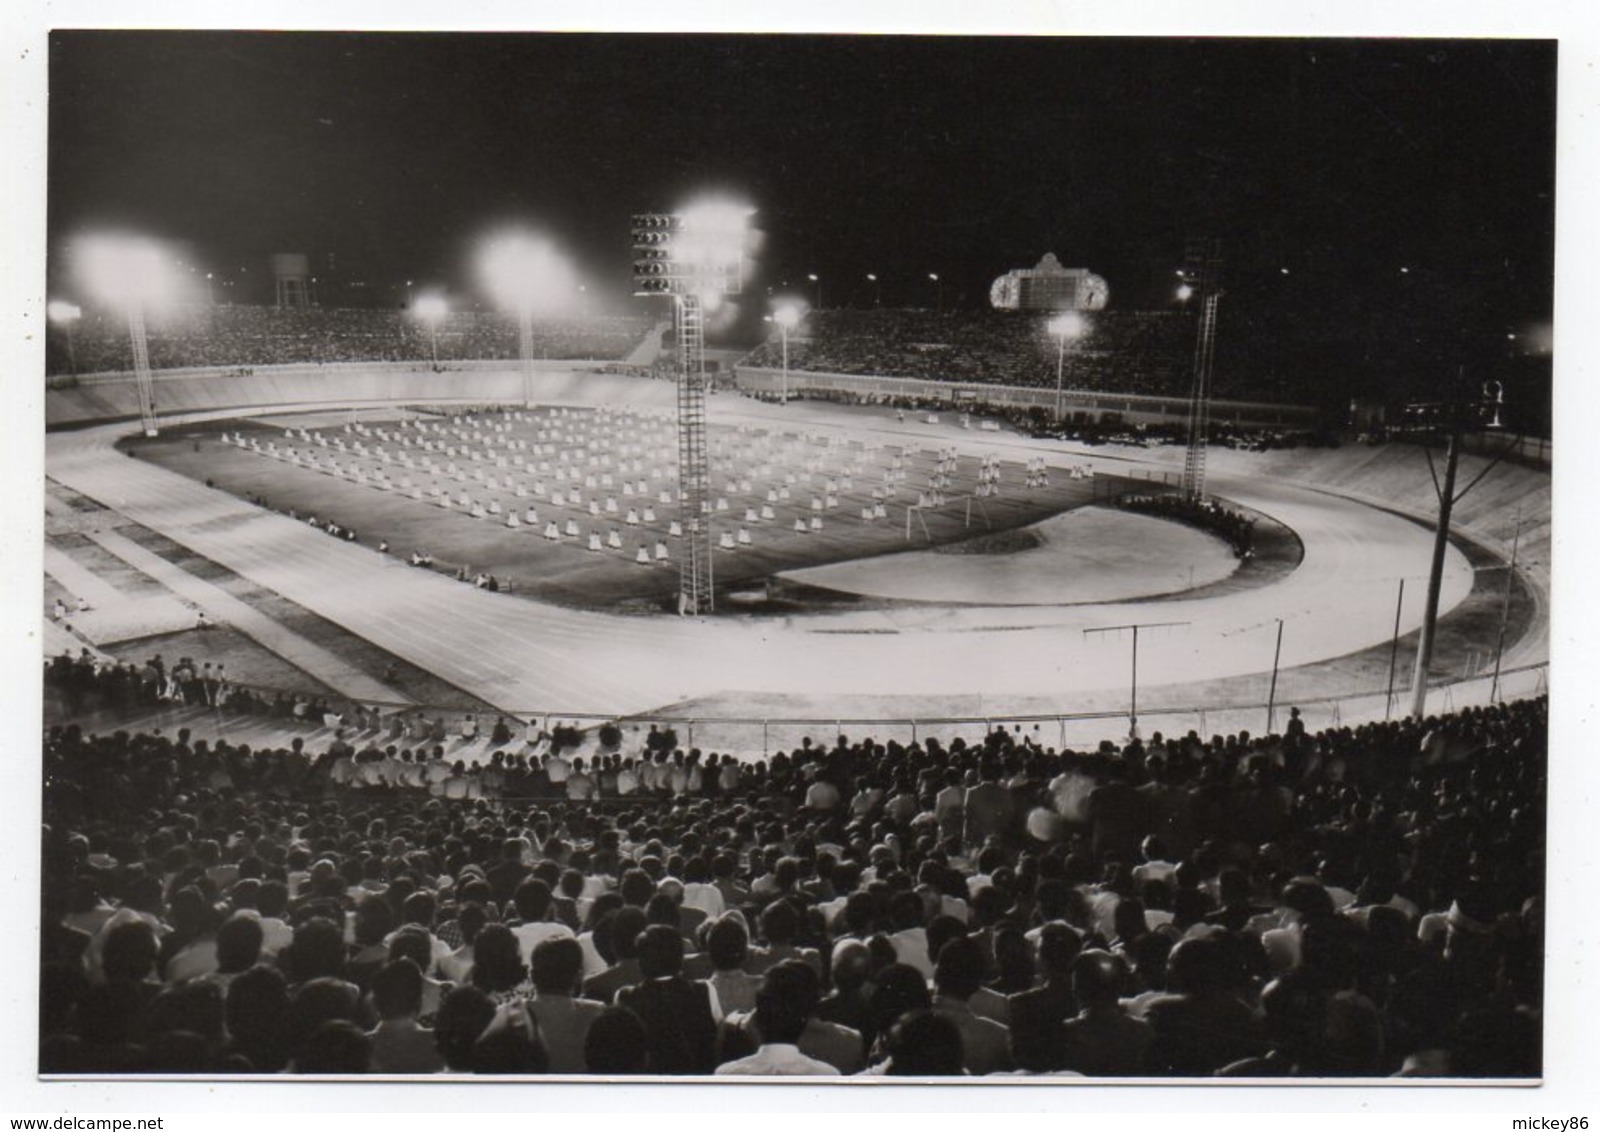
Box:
126;408;1122;611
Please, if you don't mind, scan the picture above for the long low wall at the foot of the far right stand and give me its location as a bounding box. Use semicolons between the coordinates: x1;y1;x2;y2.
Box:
734;366;1322;428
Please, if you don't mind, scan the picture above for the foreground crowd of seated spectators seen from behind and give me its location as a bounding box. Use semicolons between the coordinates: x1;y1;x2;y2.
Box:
40;699;1547;1078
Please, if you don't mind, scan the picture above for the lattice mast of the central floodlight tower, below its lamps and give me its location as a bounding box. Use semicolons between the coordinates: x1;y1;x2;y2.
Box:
674;294;714;616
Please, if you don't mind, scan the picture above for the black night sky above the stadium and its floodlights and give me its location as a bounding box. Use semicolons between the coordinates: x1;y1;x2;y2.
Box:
50;32;1555;330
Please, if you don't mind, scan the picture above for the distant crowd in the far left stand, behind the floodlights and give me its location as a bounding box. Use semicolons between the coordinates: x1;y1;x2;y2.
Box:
46;305;651;374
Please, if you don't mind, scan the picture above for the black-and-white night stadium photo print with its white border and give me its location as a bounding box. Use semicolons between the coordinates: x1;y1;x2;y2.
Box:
8;2;1589;1114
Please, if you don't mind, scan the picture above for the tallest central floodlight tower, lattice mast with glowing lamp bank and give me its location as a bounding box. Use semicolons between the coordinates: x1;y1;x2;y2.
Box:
632;201;752;616
